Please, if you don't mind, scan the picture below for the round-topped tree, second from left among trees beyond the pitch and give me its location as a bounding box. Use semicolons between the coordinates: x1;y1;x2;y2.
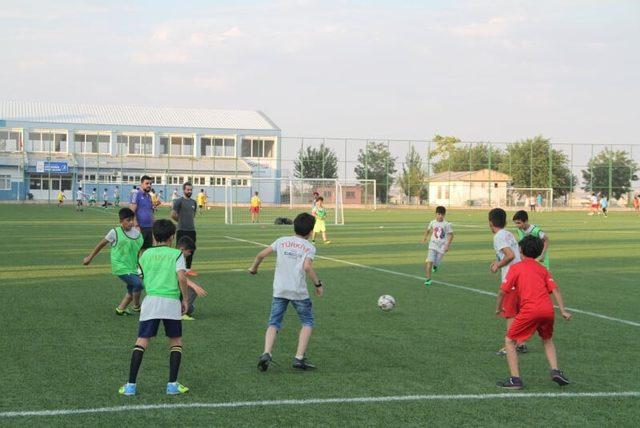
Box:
353;143;396;202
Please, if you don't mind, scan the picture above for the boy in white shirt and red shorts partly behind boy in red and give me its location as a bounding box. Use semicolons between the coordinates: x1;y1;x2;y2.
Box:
489;208;527;355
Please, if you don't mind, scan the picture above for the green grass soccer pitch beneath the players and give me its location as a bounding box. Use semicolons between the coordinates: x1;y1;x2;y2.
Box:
0;205;640;426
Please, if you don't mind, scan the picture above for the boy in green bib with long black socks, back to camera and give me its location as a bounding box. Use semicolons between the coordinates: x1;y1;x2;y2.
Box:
119;219;189;395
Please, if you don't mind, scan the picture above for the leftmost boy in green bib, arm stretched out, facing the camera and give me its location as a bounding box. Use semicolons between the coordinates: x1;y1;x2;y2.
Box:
82;208;144;315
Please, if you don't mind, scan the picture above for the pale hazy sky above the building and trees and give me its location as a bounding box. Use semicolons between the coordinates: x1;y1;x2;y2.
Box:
0;0;640;144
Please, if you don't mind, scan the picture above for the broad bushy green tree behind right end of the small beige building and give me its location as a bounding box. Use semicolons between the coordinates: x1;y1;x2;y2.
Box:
499;135;576;195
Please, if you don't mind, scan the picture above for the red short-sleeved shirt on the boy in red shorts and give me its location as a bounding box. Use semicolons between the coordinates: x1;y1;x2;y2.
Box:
500;257;557;313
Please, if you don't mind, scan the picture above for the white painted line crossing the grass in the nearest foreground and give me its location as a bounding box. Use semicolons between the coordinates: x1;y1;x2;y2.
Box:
0;391;640;418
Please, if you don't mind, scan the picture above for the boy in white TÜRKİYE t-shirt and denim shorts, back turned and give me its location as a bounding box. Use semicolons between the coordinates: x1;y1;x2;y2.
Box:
249;213;324;371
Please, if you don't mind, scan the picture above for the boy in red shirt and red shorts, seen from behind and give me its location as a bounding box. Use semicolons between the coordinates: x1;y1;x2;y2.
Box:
496;235;571;389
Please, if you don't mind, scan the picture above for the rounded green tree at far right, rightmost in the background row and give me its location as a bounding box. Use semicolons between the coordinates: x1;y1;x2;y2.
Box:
582;149;638;199
